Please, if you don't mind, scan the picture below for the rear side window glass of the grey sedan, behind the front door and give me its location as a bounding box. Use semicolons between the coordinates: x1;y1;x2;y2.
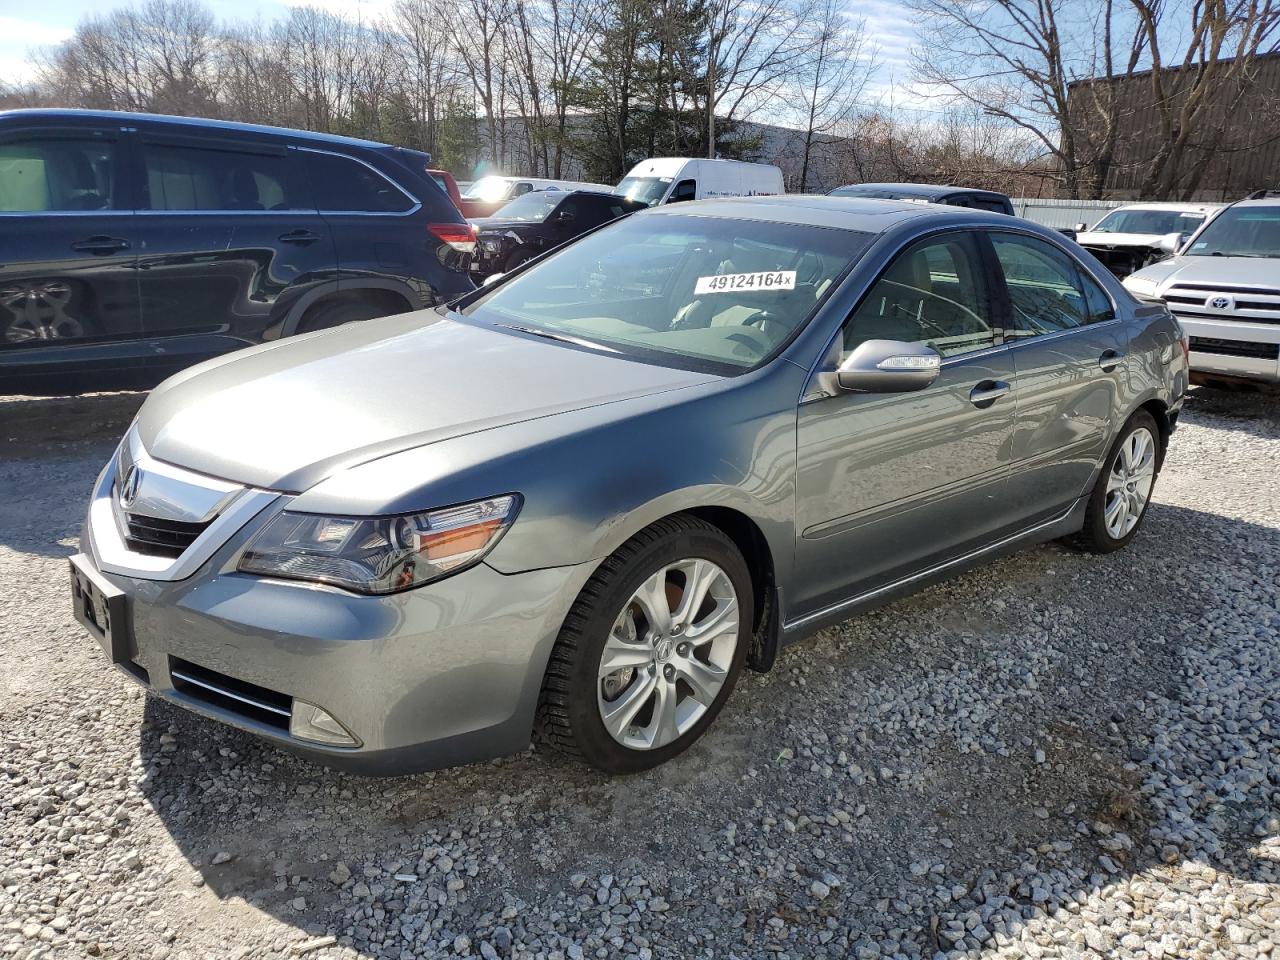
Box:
991;233;1115;339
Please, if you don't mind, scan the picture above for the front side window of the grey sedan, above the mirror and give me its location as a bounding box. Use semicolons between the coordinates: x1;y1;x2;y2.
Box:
841;232;996;360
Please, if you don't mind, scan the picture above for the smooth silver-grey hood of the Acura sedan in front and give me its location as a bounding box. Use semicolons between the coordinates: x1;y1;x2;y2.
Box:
137;312;716;492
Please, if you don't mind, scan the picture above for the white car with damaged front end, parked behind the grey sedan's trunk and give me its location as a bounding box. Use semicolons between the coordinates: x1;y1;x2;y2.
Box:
1075;204;1222;276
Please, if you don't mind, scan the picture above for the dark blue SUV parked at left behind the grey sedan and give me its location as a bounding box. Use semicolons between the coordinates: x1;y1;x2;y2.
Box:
0;104;475;393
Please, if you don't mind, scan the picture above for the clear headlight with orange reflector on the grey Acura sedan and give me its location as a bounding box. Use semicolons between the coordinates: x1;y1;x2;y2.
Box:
239;494;520;594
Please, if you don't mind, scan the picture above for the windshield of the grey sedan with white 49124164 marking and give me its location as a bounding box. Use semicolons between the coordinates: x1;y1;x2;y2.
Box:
461;215;872;374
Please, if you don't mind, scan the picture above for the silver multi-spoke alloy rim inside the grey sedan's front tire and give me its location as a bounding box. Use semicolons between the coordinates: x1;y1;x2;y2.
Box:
596;558;740;750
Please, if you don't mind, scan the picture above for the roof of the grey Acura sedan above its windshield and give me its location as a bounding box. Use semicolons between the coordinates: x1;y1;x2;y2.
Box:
636;193;1018;233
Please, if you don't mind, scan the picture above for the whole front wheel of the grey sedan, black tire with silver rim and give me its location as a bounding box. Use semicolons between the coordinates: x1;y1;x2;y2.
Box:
538;515;754;773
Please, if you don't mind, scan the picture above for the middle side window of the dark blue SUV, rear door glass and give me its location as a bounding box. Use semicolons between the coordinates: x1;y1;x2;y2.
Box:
142;143;308;210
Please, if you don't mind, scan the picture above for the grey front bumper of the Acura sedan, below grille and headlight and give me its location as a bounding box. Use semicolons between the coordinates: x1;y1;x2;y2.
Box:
79;442;590;776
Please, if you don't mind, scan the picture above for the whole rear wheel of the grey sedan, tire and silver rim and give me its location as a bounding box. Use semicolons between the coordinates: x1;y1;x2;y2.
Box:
1071;411;1162;553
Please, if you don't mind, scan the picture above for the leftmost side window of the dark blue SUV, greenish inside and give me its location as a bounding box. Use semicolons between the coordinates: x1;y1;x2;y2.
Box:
0;138;115;214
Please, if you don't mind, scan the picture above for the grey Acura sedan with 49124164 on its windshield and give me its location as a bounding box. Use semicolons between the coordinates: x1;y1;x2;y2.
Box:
70;197;1188;773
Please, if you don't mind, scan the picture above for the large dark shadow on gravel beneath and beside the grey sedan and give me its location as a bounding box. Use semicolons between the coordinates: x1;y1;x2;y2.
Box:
127;491;1280;956
